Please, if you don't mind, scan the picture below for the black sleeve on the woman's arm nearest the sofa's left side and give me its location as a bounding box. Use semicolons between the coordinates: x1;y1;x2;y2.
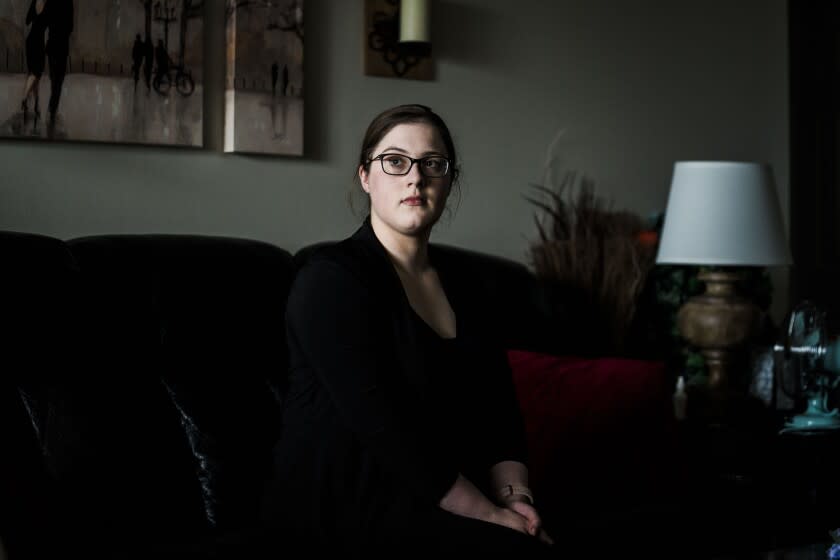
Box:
286;260;458;505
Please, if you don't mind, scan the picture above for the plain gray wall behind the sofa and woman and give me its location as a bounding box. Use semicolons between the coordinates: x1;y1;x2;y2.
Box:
0;0;789;316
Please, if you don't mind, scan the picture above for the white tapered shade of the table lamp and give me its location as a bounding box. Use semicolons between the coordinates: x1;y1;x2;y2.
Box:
656;161;792;266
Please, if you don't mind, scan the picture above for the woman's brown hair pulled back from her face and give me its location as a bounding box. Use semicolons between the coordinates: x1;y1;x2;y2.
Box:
351;103;460;218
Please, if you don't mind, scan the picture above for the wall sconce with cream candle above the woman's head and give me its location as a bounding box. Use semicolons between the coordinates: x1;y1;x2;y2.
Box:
364;0;435;80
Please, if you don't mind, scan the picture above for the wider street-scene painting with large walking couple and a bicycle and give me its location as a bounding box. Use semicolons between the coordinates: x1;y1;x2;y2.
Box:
0;0;204;147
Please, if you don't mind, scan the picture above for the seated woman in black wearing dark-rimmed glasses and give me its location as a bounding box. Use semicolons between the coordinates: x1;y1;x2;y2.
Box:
260;105;551;558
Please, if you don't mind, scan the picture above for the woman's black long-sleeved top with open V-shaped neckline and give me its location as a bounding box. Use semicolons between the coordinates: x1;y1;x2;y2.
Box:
262;220;525;540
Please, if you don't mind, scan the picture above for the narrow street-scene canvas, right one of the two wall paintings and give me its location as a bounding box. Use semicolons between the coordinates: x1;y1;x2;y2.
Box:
225;0;303;155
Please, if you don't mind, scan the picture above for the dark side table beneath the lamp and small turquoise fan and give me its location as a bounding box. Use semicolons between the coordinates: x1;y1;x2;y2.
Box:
680;396;840;552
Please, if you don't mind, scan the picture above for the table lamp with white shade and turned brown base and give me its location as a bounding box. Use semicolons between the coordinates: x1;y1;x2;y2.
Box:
656;161;791;394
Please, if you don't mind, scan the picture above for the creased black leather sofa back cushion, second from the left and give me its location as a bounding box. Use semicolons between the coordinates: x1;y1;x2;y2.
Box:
68;235;294;531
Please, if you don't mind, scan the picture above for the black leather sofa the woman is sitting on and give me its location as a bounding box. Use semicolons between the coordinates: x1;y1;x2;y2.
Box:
0;231;559;560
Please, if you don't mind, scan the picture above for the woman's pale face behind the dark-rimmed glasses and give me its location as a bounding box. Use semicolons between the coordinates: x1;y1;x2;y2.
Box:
359;123;452;236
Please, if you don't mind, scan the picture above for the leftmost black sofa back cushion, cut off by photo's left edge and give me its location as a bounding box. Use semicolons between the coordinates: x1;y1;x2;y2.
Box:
0;231;80;558
